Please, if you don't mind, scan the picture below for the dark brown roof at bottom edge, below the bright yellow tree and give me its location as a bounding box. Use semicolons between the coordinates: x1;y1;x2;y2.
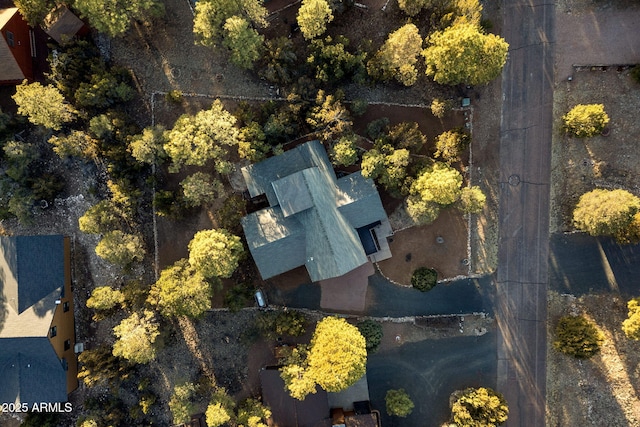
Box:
260;368;331;427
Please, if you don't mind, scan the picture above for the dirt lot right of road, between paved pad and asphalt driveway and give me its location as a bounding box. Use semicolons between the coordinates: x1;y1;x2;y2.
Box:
551;67;640;232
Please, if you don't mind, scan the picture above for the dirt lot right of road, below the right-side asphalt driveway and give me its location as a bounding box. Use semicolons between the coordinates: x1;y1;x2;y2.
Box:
547;292;640;427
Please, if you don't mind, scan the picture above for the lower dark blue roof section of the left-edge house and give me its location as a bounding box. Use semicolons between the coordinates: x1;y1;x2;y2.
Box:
0;337;67;406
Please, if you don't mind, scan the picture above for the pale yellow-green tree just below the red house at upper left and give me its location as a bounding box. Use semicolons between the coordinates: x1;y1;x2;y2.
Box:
12;80;75;130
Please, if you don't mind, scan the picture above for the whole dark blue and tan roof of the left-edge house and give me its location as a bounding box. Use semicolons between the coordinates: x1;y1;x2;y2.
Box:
0;236;67;404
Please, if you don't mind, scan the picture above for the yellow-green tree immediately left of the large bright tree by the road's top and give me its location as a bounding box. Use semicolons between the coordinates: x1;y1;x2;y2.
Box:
367;23;422;86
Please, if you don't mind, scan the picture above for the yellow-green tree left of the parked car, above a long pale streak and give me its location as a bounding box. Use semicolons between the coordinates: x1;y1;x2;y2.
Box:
149;259;213;317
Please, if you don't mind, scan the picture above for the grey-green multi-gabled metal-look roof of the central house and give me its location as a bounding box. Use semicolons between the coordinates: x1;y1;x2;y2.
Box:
242;141;387;282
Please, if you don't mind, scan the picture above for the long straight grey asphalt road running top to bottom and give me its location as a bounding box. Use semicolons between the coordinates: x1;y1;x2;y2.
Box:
495;0;555;427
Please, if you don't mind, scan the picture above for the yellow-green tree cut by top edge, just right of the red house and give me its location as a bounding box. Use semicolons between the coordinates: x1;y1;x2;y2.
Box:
73;0;164;37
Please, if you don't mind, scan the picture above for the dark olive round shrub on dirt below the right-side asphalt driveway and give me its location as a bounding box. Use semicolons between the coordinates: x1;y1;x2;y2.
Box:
553;316;604;359
